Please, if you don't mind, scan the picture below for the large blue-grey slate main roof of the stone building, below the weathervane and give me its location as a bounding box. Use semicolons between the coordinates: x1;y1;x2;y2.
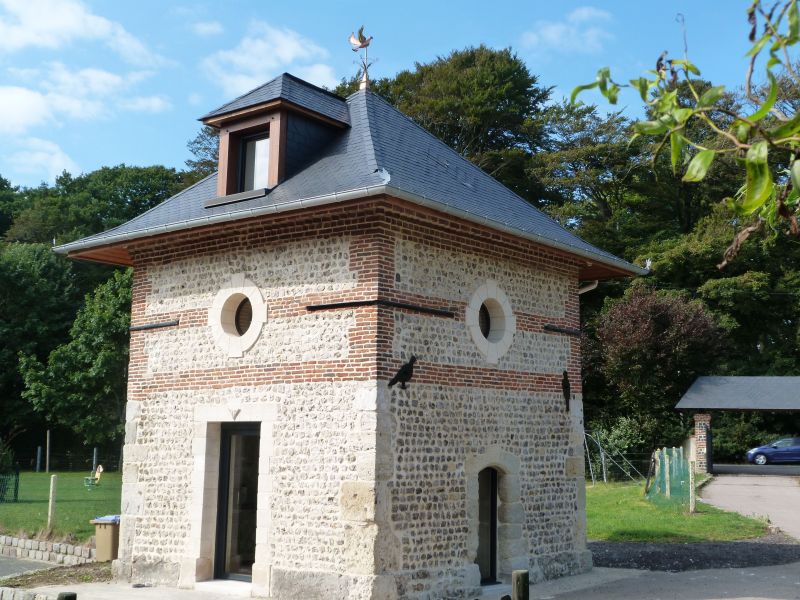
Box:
56;80;646;274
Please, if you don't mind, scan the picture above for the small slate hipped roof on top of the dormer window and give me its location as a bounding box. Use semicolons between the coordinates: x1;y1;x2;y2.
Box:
200;73;350;125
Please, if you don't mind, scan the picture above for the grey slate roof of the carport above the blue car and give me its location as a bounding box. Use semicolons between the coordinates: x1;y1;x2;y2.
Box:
675;376;800;411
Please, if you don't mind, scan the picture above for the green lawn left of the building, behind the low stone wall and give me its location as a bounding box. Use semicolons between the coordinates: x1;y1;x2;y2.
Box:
0;472;121;542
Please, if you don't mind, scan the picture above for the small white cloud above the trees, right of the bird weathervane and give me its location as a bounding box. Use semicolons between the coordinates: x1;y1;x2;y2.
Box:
522;6;614;54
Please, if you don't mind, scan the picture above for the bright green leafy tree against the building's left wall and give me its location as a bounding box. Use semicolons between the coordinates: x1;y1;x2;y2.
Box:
20;270;131;444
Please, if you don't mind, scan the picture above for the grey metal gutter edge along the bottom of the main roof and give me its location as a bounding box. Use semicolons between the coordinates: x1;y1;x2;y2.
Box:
54;185;649;277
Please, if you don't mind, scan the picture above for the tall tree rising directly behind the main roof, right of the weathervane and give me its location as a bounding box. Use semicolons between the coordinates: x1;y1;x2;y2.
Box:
333;46;550;203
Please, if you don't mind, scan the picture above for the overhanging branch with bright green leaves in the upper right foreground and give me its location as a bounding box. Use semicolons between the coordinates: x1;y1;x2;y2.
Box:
572;0;800;268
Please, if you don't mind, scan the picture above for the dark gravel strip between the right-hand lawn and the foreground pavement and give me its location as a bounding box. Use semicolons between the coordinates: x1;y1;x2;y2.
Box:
589;533;800;572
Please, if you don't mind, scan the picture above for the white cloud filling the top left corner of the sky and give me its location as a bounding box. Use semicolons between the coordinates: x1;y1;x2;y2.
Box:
0;0;167;66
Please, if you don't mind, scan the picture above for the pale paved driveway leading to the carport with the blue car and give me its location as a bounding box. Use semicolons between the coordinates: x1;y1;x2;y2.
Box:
700;475;800;540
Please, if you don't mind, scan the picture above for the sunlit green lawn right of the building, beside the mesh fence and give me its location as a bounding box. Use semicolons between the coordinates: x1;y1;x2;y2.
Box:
586;483;767;542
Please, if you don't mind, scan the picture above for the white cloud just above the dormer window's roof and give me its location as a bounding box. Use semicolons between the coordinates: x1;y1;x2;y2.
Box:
203;21;338;96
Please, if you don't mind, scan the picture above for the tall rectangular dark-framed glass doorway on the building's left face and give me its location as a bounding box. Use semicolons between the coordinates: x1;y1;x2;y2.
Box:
214;423;261;581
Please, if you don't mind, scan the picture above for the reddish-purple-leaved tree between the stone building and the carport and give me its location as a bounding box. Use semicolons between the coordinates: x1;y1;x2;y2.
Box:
584;285;725;448
